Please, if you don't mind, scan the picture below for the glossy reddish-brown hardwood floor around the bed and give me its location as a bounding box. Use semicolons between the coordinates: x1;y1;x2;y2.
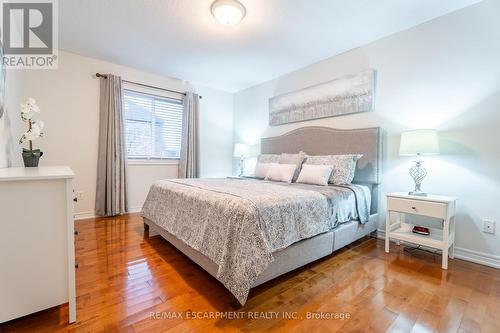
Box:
0;215;500;332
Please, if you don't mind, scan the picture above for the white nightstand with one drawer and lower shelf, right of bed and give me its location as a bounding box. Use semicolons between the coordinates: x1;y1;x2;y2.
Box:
385;192;457;269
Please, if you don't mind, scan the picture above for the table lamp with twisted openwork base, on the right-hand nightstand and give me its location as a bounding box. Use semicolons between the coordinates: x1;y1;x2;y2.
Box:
399;129;439;196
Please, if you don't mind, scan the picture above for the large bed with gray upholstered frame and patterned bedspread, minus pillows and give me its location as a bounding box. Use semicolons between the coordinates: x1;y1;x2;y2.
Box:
142;127;381;305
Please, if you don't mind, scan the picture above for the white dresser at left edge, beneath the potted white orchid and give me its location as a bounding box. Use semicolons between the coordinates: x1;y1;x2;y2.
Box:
0;166;76;323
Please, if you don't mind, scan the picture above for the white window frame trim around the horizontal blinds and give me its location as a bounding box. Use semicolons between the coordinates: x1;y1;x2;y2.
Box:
122;83;183;166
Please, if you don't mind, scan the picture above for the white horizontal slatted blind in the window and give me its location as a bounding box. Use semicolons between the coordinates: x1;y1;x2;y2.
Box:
123;90;182;159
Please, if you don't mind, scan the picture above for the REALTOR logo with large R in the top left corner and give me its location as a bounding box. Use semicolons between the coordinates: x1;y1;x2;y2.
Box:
0;0;57;69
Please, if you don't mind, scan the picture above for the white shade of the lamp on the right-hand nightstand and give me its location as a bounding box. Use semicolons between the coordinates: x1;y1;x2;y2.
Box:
399;130;439;156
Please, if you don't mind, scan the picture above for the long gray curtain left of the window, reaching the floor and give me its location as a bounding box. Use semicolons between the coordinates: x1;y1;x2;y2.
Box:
95;74;127;216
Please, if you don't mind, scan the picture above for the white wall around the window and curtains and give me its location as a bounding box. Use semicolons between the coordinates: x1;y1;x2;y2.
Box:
14;51;233;216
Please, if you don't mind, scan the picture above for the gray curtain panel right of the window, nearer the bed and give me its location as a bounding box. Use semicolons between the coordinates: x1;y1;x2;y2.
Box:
179;92;200;178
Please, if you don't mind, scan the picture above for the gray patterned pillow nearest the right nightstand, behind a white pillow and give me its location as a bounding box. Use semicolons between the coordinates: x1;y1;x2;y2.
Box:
305;154;363;185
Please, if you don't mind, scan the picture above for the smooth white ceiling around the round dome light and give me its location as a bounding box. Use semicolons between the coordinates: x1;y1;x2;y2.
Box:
59;0;480;92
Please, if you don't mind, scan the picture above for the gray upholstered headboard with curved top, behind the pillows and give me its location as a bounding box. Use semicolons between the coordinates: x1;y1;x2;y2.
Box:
260;126;382;185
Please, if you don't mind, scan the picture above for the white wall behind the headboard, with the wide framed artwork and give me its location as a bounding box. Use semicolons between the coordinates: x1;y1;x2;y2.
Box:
234;0;500;263
